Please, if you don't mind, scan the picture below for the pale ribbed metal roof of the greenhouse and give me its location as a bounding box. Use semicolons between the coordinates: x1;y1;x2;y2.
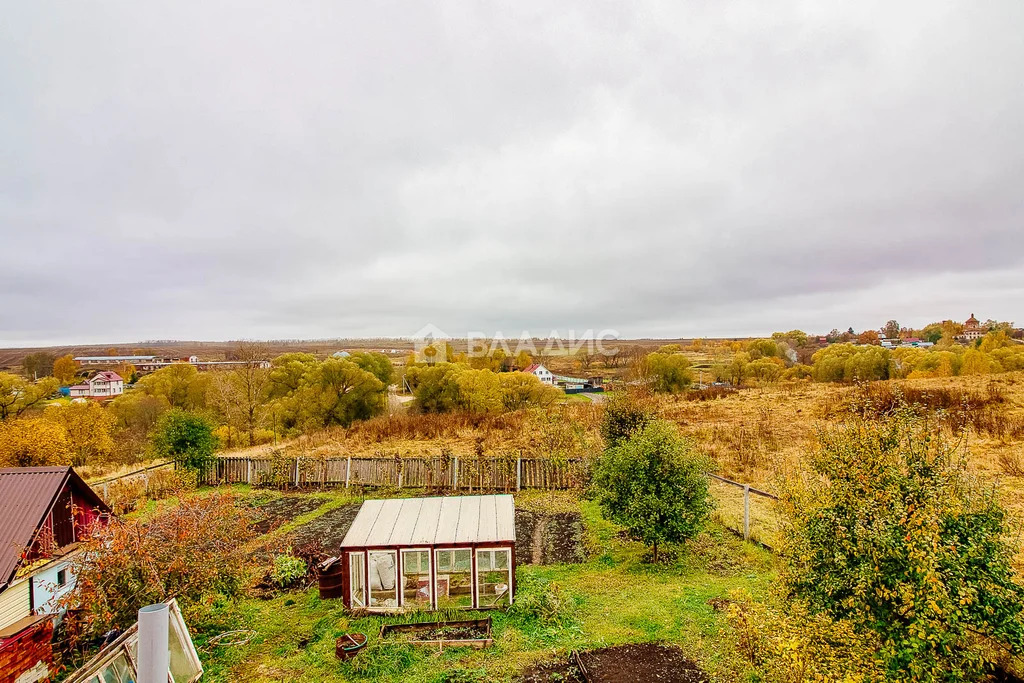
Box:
341;495;515;548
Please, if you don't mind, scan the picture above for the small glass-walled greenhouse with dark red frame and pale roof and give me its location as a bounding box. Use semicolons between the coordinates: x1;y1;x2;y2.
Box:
338;496;515;612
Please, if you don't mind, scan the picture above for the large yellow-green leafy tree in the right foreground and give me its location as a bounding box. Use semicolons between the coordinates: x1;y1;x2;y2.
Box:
781;407;1024;682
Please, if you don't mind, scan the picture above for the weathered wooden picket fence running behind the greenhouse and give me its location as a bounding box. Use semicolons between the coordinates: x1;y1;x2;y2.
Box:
204;456;589;493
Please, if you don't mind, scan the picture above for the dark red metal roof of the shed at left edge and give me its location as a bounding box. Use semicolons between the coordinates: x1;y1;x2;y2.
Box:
0;467;110;588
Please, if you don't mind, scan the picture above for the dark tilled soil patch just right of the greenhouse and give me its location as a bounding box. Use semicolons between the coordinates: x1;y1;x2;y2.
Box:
515;510;587;564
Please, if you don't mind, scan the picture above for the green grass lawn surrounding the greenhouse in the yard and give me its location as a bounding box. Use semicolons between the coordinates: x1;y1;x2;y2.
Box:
186;494;776;683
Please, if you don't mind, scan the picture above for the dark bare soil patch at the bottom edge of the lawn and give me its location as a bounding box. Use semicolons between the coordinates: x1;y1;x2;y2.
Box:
522;643;711;683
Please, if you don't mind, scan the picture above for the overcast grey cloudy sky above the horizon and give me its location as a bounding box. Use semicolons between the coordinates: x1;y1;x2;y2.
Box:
0;0;1024;345
